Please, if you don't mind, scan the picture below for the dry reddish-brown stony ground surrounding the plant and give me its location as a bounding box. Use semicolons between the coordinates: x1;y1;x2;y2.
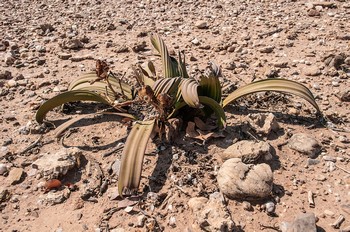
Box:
0;0;350;232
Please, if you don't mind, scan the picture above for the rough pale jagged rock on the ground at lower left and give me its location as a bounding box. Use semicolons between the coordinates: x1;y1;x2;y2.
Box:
32;148;82;179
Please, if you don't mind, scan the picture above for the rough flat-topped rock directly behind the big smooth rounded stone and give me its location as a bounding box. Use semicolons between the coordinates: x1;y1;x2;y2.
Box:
220;140;272;163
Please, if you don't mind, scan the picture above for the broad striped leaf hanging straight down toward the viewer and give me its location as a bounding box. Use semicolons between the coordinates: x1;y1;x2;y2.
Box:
118;120;155;195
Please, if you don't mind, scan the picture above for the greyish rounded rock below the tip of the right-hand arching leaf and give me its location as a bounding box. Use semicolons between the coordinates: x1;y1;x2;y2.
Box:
288;133;321;158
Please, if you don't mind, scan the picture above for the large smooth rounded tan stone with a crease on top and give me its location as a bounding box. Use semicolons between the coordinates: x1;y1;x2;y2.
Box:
217;158;273;199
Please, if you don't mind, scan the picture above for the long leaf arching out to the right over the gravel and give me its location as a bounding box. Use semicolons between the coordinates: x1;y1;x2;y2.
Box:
222;79;320;112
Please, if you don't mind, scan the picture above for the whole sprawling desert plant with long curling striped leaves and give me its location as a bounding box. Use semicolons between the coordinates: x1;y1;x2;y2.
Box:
36;34;320;195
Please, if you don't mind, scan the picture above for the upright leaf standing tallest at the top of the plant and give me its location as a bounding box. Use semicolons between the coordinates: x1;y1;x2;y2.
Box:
151;34;180;78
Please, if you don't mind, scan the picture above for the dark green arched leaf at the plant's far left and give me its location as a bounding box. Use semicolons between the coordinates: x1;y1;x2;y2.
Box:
35;90;110;123
